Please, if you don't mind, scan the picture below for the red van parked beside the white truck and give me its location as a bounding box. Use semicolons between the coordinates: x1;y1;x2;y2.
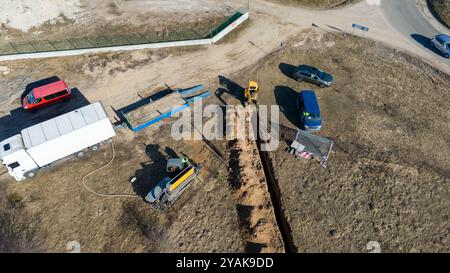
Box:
22;80;71;111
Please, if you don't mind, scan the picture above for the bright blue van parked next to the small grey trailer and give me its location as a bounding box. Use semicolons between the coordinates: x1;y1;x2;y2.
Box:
297;90;322;132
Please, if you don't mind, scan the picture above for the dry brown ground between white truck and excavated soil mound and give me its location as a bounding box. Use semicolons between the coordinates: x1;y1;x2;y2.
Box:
0;111;244;252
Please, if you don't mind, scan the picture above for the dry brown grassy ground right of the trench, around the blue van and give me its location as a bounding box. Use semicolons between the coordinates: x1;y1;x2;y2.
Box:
227;29;450;252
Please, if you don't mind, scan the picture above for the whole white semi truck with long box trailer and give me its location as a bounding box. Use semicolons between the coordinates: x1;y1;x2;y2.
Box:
0;102;116;181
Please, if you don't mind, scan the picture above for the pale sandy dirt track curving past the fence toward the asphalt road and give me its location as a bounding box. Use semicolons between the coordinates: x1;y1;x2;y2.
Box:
2;0;450;115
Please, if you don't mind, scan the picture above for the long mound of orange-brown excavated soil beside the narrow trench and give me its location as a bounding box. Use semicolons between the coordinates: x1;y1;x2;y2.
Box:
228;106;285;253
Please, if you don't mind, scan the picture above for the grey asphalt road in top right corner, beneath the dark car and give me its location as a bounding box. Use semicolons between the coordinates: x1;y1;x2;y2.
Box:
381;0;450;67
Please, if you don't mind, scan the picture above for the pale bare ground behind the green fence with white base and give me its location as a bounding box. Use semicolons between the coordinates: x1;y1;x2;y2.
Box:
0;0;240;44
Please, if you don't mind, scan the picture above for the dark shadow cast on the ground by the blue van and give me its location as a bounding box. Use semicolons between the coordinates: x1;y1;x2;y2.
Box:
274;85;301;128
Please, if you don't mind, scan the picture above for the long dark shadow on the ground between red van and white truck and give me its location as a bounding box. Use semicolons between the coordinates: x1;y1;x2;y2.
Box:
0;86;90;140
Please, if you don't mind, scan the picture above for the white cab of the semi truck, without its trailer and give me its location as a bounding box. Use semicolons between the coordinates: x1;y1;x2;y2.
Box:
0;135;39;181
